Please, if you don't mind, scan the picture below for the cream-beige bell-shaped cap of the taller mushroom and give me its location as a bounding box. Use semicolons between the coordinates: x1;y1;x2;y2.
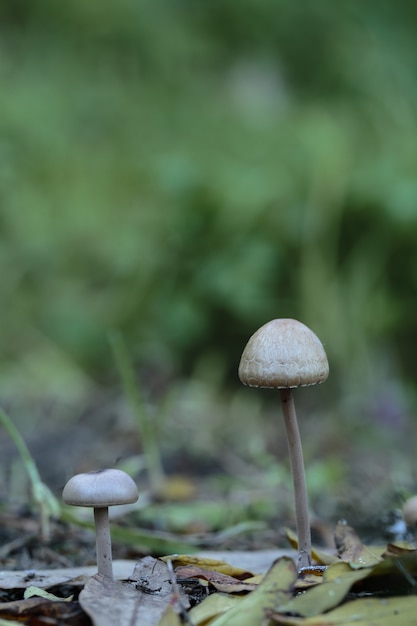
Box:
239;318;329;389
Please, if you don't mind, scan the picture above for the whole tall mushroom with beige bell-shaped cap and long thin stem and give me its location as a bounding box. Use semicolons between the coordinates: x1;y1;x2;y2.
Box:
239;319;329;569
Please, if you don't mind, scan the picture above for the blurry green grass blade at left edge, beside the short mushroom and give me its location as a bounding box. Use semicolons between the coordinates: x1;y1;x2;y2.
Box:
0;409;61;541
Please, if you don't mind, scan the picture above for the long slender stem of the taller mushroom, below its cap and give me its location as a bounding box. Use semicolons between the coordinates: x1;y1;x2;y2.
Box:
280;388;311;569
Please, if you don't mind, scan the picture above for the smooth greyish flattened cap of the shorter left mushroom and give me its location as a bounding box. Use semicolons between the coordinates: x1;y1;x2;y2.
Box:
62;469;139;508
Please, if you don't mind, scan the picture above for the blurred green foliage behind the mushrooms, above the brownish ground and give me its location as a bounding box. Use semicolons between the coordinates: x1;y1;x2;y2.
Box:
0;0;417;410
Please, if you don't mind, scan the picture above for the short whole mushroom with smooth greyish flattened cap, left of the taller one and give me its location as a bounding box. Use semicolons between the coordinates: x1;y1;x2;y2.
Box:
62;469;139;580
